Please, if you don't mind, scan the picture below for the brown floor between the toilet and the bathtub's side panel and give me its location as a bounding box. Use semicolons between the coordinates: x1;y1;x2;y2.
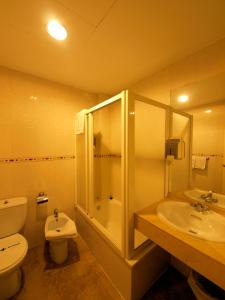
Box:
13;237;121;300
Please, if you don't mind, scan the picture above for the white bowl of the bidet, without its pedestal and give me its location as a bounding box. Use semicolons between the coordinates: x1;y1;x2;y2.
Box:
45;213;77;240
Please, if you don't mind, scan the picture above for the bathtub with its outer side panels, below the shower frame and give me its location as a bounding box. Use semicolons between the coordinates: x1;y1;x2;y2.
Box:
75;204;170;300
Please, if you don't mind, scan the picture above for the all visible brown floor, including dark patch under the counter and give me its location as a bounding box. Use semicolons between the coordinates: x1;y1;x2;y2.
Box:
13;236;195;300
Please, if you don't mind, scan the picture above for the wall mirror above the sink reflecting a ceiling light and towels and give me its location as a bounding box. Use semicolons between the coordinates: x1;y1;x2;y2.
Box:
171;73;225;208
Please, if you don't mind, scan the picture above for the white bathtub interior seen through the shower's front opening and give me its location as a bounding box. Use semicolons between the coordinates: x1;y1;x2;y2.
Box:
94;199;122;249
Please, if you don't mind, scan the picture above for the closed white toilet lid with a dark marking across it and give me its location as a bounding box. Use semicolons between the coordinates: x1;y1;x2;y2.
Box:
0;233;28;274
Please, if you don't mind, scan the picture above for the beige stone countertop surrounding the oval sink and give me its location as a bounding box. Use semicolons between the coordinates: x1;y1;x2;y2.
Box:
135;196;225;289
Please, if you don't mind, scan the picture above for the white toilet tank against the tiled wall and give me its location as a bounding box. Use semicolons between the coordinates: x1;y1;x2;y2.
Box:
0;197;27;238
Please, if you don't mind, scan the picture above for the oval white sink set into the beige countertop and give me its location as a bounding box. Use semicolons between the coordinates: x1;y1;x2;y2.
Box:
157;201;225;242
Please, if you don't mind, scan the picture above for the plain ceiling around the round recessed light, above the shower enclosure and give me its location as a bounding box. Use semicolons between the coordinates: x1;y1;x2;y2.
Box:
0;0;225;93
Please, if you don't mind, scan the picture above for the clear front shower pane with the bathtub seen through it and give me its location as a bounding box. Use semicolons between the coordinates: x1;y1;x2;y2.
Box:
92;101;122;248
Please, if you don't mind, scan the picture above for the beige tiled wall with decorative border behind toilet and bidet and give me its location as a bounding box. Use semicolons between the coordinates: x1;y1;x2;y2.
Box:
0;67;96;247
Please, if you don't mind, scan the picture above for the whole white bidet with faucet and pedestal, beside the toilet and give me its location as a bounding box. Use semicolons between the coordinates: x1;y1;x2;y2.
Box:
45;209;77;264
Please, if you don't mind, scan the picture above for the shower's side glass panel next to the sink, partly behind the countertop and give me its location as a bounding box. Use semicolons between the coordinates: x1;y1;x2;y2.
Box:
134;100;166;248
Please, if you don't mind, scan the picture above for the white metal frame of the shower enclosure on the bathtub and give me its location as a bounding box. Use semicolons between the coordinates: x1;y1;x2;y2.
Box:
76;90;192;259
